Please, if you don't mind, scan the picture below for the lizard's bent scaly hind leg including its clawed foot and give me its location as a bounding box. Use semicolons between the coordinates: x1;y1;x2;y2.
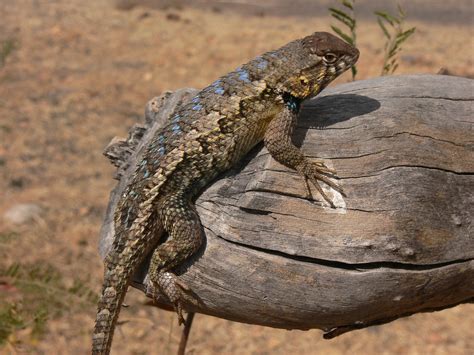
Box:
149;194;204;324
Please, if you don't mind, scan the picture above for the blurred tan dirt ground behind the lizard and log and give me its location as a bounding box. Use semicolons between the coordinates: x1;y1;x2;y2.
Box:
0;0;474;354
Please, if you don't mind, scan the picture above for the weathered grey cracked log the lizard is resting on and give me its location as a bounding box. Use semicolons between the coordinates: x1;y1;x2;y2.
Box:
100;75;474;337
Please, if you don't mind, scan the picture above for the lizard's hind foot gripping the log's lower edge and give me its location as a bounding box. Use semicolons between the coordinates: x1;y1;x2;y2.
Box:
154;272;196;325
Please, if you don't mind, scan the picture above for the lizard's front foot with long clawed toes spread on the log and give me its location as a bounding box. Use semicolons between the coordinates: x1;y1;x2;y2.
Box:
296;160;346;208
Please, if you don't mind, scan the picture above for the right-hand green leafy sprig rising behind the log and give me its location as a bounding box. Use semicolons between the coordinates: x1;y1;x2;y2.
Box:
374;5;416;75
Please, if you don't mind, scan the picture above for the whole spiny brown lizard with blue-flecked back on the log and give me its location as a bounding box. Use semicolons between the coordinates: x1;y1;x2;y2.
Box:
92;32;359;354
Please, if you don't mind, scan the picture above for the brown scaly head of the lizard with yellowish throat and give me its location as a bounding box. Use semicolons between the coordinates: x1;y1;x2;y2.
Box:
285;32;359;99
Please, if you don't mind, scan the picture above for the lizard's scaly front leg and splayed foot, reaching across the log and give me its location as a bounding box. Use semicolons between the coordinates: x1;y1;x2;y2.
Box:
264;105;344;208
